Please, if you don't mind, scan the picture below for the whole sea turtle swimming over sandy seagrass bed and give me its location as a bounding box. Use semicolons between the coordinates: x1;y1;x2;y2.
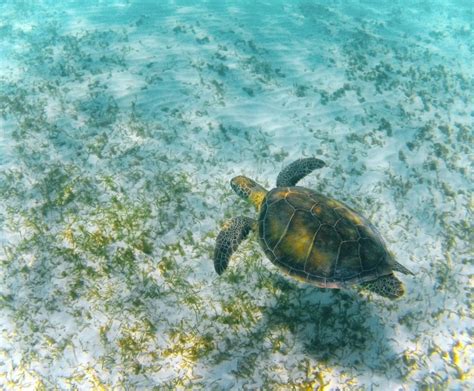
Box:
214;158;413;299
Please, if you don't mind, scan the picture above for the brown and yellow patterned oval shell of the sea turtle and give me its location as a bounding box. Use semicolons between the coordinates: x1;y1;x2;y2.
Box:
258;186;392;288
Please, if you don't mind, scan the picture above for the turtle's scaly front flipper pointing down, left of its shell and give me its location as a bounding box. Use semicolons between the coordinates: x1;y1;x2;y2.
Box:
214;216;256;275
